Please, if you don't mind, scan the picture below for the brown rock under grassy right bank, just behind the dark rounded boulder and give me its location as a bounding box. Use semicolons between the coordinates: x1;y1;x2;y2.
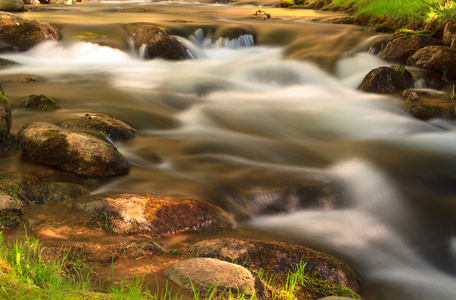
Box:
382;34;442;64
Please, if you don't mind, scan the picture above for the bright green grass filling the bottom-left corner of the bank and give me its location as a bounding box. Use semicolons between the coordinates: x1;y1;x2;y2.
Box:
0;232;181;300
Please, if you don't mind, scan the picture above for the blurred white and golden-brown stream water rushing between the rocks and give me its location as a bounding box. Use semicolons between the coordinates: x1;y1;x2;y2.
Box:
0;1;456;299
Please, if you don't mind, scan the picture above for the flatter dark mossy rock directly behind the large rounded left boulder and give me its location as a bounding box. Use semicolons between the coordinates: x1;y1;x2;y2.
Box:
59;113;136;140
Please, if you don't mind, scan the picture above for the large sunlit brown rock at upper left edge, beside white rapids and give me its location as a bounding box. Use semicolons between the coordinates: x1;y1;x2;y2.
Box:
0;12;60;51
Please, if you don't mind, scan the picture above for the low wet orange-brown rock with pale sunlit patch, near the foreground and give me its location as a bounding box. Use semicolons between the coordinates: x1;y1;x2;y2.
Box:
76;194;233;237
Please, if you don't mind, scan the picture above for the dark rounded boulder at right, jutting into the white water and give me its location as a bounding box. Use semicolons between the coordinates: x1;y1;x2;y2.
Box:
358;66;413;94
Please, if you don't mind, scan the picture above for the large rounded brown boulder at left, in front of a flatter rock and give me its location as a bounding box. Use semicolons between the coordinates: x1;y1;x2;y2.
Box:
17;122;130;176
